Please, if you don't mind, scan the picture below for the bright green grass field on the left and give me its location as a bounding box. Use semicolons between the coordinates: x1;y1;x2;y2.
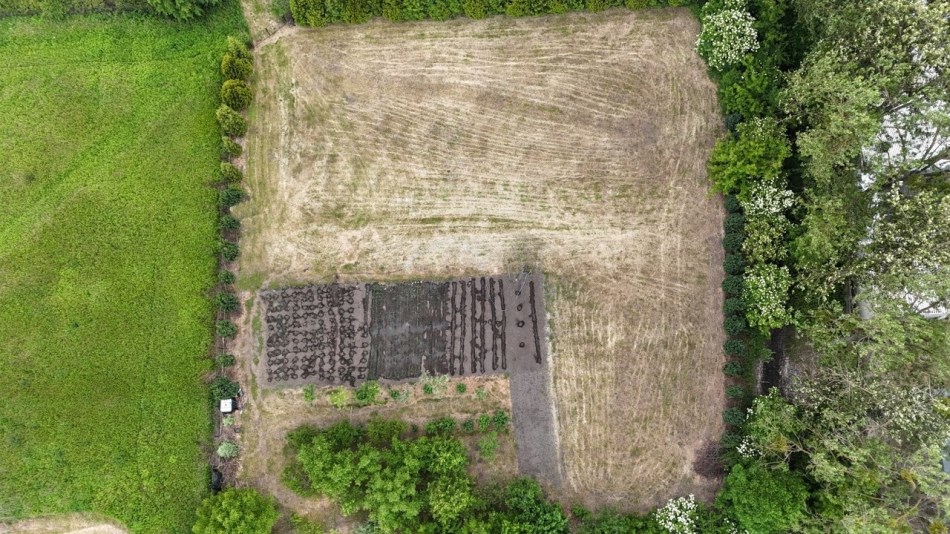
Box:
0;2;247;533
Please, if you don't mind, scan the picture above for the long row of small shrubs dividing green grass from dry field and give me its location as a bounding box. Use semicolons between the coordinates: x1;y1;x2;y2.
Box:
210;37;253;460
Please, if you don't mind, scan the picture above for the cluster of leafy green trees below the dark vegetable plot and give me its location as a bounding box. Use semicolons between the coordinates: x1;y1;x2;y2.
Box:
284;419;567;533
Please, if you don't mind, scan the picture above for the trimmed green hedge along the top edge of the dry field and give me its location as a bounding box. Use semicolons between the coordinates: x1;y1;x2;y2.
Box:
290;0;694;26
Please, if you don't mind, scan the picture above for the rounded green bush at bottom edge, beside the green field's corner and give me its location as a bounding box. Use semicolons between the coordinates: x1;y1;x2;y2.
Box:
192;490;279;534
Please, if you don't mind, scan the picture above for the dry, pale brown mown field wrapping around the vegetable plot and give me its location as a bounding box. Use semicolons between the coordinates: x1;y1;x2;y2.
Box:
240;6;725;508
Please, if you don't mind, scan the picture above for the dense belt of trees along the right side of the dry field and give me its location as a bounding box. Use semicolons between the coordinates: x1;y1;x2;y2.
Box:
698;0;950;532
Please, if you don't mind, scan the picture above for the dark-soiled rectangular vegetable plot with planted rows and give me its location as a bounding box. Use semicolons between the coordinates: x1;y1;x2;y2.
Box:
261;275;546;386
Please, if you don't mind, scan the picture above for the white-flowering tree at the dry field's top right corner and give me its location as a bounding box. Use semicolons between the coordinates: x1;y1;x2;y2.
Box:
696;0;759;71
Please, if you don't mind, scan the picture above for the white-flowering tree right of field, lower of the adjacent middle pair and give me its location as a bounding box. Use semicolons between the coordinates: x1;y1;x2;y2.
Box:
742;263;792;332
